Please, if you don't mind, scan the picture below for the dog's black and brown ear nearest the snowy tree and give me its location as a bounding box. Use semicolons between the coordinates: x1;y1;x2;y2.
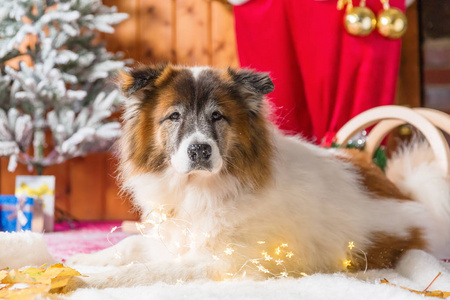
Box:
119;64;172;97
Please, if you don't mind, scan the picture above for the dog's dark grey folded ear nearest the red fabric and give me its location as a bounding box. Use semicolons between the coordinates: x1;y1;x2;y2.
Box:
228;68;275;113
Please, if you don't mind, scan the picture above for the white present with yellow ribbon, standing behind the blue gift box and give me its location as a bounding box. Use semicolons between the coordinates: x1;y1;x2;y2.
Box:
16;176;55;232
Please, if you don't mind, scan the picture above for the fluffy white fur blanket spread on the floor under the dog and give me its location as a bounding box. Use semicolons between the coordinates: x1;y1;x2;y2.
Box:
0;233;450;300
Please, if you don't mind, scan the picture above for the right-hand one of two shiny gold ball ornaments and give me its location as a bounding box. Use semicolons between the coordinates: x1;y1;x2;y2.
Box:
377;8;408;39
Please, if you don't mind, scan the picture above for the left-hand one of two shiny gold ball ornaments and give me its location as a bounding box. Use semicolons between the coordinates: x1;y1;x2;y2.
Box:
344;6;377;36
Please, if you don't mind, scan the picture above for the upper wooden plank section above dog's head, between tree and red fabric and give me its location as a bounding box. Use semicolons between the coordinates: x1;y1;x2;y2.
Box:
104;0;238;67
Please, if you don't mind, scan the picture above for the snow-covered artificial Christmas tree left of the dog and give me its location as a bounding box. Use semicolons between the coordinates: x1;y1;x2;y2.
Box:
0;0;128;173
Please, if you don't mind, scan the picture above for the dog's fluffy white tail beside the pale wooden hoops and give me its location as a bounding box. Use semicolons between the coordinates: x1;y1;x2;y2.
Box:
386;140;450;258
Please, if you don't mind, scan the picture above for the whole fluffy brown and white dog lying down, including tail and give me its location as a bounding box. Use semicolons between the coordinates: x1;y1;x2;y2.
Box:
69;65;450;287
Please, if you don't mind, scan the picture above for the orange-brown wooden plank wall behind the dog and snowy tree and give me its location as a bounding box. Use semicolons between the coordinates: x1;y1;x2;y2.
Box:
0;0;238;220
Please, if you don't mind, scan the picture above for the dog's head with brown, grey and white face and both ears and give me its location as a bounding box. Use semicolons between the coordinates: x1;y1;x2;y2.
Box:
122;65;274;185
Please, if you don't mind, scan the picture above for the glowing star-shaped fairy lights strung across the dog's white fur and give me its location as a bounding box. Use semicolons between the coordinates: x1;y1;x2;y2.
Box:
107;205;368;284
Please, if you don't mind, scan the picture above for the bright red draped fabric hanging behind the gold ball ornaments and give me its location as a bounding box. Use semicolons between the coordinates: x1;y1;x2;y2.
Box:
234;0;405;141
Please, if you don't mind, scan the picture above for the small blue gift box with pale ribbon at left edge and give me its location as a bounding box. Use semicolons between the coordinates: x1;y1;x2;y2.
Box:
0;195;34;232
